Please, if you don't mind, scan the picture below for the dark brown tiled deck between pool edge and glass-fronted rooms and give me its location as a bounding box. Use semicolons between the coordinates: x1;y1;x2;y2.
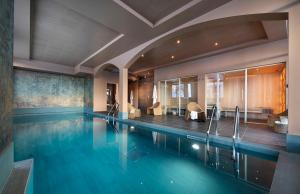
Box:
135;115;286;150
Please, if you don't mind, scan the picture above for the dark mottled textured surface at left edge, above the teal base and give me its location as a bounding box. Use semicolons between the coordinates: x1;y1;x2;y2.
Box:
0;0;14;153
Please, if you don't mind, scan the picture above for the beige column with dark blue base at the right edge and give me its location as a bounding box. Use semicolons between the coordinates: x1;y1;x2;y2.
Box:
287;4;300;153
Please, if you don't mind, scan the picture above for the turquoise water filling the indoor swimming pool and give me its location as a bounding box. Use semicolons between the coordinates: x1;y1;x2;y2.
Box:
14;115;276;194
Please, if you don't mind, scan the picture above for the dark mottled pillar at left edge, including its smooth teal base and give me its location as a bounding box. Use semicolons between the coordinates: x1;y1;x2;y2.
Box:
0;0;14;193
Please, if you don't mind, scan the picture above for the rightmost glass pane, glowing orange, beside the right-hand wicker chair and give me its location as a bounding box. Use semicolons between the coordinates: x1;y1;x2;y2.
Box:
247;64;286;123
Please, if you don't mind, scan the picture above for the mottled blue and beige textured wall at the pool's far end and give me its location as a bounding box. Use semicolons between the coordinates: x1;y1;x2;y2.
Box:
13;69;93;109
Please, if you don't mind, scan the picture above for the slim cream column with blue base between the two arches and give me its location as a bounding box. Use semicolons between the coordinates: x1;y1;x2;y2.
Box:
119;68;128;119
